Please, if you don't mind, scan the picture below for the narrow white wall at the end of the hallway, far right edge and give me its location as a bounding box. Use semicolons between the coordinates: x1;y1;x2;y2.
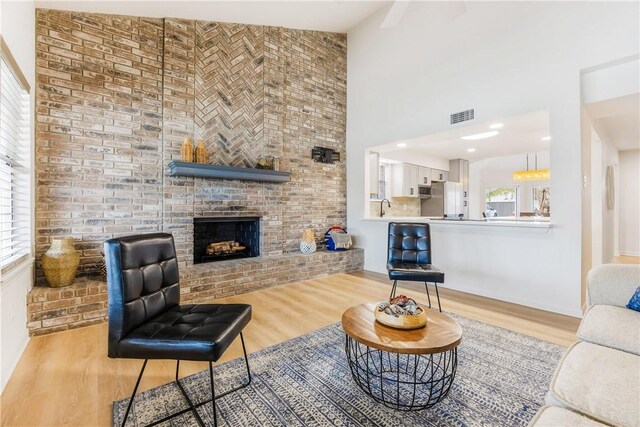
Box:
616;150;640;256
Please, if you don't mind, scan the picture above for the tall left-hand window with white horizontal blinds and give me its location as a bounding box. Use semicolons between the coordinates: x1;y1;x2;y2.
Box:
0;37;31;271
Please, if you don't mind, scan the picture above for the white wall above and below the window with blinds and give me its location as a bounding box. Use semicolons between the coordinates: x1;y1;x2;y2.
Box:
0;0;36;390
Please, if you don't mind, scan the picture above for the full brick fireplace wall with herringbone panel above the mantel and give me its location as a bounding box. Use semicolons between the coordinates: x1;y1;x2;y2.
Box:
36;9;347;284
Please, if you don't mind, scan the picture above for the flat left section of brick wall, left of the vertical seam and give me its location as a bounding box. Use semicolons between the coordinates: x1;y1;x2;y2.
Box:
36;11;163;284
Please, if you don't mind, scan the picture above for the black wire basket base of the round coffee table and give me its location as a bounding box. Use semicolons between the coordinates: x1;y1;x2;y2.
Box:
345;335;458;411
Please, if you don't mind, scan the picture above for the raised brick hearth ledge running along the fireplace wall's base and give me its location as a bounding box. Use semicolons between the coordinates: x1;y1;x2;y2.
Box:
27;248;364;335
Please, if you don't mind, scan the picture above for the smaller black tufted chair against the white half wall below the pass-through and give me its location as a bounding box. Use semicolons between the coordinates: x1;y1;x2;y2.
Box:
387;222;444;311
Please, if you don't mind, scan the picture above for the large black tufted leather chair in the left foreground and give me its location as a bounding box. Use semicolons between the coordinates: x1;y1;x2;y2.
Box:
104;233;251;426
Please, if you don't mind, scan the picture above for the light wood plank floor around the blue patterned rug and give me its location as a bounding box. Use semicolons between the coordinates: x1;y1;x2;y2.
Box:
1;272;579;426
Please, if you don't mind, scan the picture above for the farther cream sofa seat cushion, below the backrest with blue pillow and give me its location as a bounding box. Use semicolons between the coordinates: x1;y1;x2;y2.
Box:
578;305;640;355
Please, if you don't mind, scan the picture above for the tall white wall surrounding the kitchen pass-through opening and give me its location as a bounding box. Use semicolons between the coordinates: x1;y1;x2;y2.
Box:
347;2;640;315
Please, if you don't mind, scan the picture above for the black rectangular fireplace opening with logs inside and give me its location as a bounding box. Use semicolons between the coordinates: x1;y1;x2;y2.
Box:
193;217;260;264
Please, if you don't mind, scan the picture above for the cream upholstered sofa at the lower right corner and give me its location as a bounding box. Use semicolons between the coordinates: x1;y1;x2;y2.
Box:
530;264;640;427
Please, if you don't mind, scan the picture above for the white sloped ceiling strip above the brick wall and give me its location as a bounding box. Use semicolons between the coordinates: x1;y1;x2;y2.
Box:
36;0;392;33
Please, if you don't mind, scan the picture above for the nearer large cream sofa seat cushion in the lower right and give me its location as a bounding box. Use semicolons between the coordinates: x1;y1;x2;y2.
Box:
547;342;640;427
